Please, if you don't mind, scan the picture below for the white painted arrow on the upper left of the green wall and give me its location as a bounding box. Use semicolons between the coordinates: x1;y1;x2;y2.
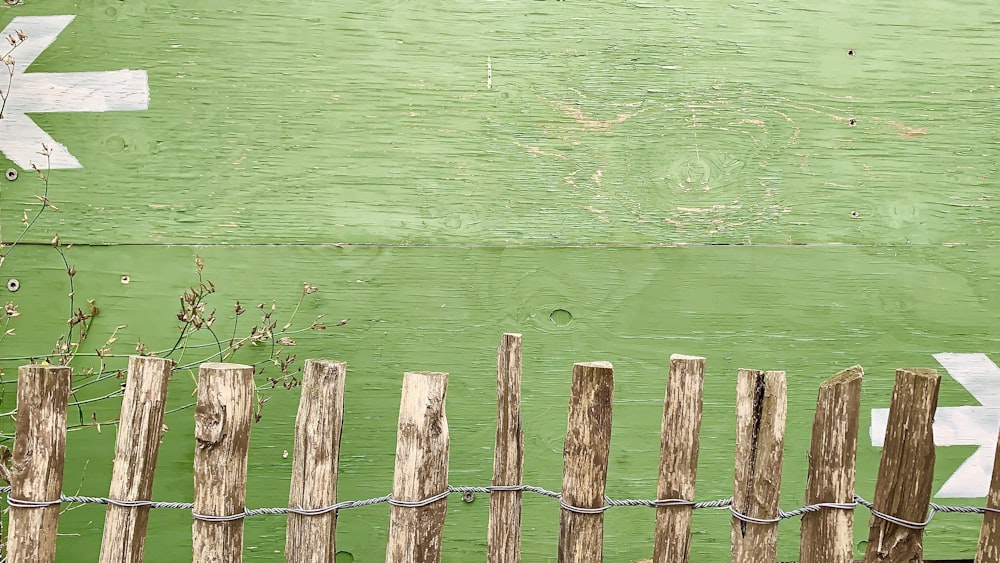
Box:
0;16;149;169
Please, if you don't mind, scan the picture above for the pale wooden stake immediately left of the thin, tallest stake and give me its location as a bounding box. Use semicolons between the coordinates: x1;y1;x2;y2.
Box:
385;372;449;563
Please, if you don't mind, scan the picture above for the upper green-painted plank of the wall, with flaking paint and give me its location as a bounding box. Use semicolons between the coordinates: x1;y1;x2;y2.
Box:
0;0;1000;245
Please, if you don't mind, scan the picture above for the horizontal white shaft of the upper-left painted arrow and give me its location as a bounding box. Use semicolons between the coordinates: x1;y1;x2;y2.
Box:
13;70;149;113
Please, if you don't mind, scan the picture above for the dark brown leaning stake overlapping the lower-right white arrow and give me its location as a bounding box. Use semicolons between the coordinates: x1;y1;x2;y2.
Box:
864;369;941;563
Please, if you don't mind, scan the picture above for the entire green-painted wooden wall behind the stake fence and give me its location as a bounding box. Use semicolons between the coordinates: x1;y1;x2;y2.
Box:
0;0;1000;563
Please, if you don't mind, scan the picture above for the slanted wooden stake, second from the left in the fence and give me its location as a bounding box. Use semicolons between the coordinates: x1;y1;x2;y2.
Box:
100;356;174;563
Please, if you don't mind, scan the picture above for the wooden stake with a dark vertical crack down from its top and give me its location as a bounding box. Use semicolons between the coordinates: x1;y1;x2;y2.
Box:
732;369;788;563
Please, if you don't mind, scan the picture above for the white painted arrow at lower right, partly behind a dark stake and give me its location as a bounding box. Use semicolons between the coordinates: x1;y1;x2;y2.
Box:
871;353;1000;498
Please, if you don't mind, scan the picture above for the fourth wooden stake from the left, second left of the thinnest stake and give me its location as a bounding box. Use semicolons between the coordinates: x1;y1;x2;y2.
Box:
285;360;347;563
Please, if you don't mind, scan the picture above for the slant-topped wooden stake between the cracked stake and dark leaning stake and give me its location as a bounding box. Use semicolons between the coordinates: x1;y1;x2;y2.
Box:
799;366;864;563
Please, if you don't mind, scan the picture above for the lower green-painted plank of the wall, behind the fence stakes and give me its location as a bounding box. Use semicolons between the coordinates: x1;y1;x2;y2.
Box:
0;246;1000;561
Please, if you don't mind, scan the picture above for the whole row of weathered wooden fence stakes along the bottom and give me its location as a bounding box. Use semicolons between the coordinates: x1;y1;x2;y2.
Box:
0;334;1000;563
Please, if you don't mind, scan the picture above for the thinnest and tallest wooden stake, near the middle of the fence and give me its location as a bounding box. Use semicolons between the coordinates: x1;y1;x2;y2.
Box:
486;334;524;563
